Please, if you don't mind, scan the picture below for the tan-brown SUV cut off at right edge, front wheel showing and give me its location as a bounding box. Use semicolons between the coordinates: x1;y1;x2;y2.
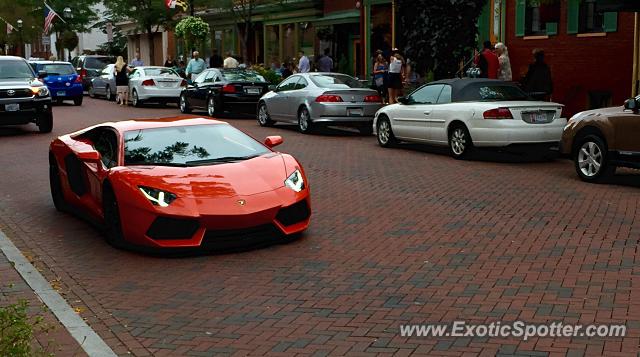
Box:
561;96;640;182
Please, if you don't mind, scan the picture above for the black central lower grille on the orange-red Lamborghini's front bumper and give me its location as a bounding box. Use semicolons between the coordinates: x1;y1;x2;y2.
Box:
201;224;282;250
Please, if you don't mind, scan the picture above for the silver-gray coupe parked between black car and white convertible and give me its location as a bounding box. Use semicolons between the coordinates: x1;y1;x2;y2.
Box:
257;72;383;134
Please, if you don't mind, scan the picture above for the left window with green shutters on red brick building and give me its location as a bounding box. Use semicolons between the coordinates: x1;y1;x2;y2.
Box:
524;0;560;36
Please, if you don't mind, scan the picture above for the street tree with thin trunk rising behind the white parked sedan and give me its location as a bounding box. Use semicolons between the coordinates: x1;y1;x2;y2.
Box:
104;0;177;64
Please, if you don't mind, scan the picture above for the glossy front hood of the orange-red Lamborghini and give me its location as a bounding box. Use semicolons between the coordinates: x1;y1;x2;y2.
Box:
121;153;287;198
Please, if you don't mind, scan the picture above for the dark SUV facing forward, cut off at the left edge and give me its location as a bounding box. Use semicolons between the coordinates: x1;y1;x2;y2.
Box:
0;56;53;133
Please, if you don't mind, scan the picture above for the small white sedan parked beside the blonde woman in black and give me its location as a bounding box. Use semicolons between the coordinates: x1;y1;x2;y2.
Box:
129;66;187;107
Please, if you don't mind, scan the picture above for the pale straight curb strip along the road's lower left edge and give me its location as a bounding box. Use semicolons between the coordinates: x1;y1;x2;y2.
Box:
0;231;116;357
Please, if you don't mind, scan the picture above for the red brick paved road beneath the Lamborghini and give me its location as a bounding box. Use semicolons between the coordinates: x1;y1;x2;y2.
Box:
0;99;640;356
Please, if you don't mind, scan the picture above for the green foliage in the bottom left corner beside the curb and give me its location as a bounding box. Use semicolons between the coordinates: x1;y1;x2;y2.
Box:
0;300;53;357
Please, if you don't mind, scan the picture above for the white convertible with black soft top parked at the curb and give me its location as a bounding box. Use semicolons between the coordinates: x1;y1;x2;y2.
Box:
373;78;567;158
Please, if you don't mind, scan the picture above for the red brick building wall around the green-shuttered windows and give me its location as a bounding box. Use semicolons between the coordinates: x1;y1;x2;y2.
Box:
505;1;634;115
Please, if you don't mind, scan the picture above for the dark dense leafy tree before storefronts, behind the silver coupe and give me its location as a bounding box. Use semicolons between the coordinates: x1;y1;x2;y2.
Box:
398;0;487;79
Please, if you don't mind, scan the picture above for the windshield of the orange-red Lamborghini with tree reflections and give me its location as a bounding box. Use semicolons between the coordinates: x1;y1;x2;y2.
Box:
124;124;269;166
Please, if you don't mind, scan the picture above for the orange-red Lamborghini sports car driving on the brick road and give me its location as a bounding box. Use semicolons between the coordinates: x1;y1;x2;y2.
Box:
49;116;311;249
